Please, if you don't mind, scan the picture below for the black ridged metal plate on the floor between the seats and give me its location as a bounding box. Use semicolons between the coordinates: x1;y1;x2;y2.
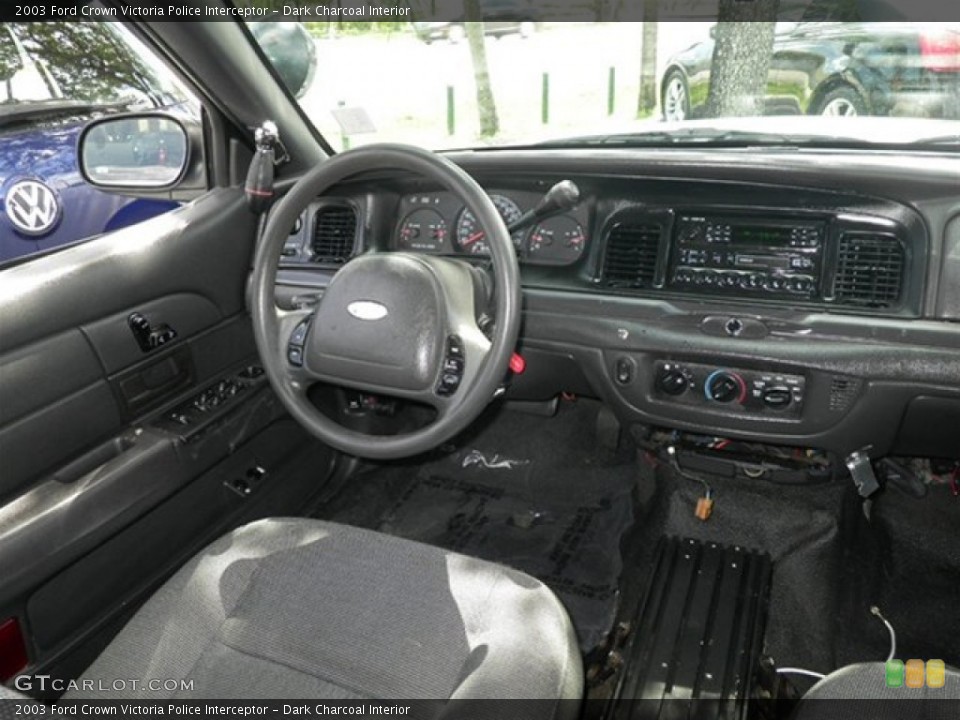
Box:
612;537;773;720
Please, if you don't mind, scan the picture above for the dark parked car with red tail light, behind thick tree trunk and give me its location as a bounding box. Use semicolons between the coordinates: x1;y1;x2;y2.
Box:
660;22;960;121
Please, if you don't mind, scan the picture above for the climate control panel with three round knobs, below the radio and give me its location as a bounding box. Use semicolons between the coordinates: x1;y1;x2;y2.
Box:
653;360;806;416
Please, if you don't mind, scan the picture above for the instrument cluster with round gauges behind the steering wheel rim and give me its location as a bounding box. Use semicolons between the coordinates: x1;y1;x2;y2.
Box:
391;191;588;266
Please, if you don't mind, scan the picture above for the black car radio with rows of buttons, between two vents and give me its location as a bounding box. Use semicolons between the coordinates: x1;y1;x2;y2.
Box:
667;215;826;299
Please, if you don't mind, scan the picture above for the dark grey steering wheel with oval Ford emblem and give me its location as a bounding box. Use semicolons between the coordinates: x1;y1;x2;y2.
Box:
252;144;521;459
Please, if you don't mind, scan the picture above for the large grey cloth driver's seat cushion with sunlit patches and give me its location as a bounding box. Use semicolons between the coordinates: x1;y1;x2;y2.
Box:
65;519;583;705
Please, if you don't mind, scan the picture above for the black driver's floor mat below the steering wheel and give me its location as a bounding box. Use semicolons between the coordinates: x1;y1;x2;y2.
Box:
322;400;635;652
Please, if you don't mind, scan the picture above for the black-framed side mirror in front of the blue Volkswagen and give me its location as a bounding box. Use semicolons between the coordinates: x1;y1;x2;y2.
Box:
77;112;206;196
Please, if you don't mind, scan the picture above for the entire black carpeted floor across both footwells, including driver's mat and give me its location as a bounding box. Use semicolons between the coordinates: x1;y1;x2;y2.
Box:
320;401;960;688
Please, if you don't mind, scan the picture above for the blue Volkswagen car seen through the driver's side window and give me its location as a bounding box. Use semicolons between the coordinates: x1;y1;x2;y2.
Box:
0;22;194;263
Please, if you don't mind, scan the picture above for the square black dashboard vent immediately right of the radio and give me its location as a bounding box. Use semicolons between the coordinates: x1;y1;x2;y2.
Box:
833;233;906;308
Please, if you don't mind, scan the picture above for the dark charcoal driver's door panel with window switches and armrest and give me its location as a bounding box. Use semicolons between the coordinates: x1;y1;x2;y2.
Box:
0;189;322;670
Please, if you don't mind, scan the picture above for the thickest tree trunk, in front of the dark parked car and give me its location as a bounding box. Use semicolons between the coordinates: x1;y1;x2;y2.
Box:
706;0;779;117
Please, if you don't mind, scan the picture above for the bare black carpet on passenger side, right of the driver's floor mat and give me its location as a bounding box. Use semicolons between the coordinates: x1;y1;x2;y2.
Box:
628;452;960;688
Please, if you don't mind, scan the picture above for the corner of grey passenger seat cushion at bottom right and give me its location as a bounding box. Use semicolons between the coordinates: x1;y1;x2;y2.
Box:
793;662;960;720
